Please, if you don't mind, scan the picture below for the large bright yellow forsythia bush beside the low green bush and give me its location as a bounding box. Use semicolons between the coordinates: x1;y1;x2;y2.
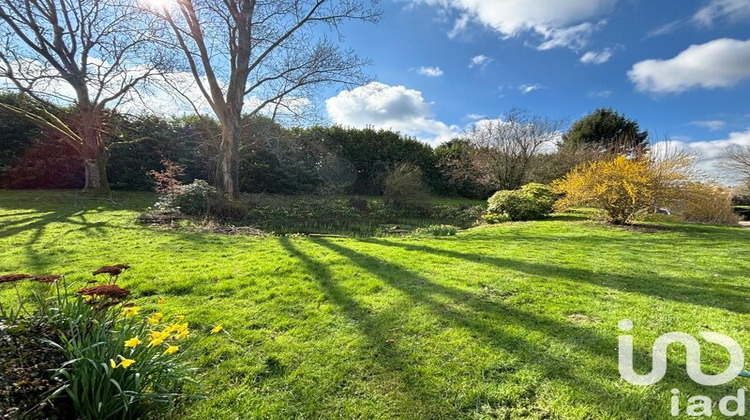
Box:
553;156;689;224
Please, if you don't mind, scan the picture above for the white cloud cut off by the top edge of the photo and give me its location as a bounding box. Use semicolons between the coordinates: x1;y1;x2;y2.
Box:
410;0;616;49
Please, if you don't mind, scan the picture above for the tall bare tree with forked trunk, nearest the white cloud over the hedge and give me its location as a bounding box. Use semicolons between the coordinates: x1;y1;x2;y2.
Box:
155;0;379;197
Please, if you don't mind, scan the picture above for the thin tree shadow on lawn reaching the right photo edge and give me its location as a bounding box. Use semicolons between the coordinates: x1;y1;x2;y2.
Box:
364;238;750;314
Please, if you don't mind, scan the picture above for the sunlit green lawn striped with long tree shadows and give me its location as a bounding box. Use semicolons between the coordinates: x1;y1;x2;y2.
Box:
0;191;750;419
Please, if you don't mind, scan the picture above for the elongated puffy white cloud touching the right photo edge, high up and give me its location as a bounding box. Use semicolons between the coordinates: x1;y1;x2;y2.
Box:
628;38;750;93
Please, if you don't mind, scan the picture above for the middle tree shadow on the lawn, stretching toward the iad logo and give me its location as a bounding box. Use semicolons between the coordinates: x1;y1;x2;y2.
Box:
311;238;744;418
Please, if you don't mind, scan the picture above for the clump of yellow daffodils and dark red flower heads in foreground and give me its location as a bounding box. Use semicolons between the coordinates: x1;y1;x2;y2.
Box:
0;264;203;419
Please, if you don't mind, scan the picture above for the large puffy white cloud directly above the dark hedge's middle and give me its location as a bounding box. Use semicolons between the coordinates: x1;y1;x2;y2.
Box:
326;82;459;144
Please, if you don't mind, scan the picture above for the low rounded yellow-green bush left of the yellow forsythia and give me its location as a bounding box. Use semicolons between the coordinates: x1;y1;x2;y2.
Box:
485;183;557;220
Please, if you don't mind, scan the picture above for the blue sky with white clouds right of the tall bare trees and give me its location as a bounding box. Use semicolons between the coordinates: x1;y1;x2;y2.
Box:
327;0;750;174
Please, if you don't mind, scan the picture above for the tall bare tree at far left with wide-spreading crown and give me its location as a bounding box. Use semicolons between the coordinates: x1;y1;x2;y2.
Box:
0;0;166;190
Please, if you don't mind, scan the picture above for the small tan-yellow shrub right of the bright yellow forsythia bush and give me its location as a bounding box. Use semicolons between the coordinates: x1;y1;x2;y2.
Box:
682;182;740;225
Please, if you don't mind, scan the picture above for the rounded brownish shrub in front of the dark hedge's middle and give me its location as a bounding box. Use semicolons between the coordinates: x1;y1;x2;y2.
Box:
383;163;429;212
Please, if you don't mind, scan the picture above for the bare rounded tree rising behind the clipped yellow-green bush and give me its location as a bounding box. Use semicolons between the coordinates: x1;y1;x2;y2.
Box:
466;109;562;190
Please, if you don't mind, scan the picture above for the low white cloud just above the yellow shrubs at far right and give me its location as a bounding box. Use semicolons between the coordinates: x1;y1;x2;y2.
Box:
652;128;750;178
